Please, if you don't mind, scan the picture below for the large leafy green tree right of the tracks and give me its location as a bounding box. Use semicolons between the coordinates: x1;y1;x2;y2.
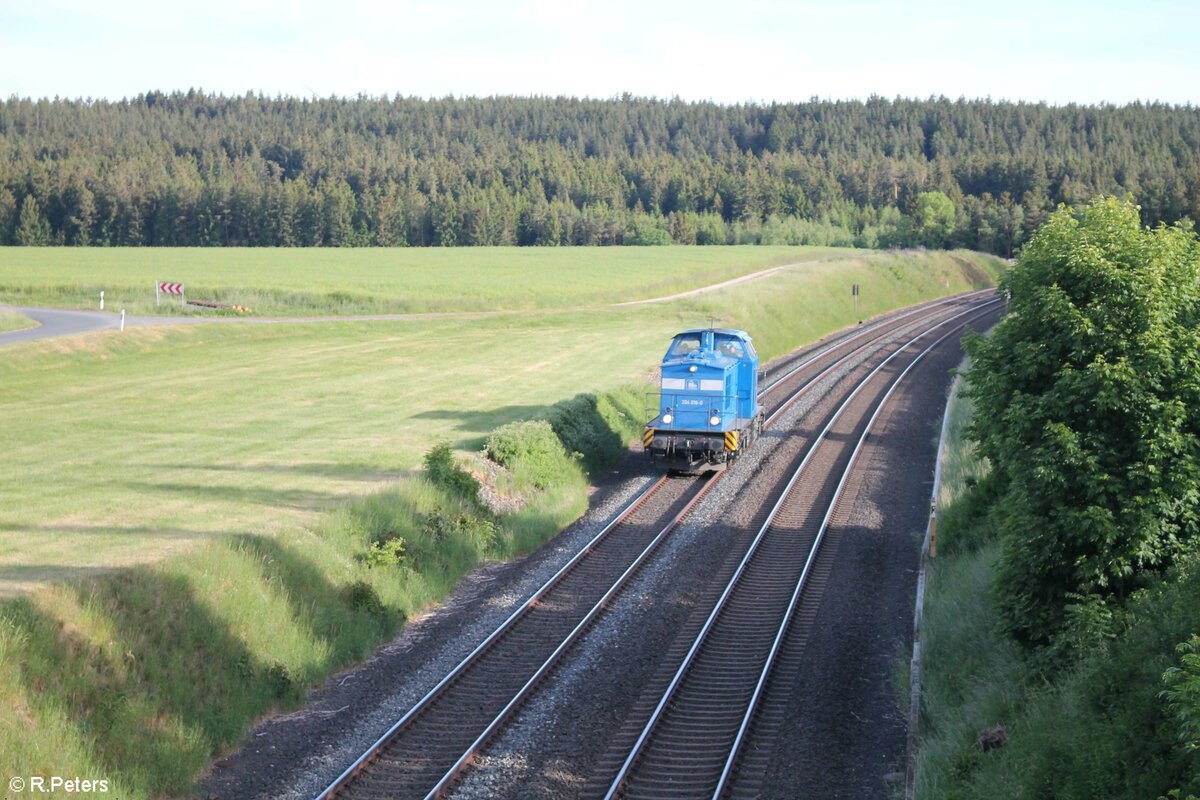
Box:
967;198;1200;645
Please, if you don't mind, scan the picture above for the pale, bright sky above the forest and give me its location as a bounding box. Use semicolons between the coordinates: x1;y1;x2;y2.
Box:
0;0;1200;106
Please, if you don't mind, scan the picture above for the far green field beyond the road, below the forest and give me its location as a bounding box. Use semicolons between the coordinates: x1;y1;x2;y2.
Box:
0;247;854;315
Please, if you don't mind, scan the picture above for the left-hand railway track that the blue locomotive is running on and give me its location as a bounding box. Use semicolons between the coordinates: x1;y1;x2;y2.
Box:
318;293;998;800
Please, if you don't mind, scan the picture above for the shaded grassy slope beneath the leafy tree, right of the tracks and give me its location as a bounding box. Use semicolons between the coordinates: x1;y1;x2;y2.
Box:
917;364;1200;800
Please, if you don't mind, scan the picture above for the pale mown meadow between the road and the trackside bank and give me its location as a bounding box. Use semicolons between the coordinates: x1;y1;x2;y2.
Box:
0;254;988;594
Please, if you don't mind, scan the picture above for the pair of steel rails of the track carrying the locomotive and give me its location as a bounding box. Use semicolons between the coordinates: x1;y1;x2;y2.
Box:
316;293;993;800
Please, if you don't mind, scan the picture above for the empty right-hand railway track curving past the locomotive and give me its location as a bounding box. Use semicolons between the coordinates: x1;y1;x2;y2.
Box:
600;302;992;800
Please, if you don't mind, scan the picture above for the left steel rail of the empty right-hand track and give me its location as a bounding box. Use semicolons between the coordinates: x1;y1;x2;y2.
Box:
605;300;1000;800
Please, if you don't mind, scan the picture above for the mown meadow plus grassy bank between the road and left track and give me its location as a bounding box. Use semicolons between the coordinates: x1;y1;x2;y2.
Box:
0;247;996;798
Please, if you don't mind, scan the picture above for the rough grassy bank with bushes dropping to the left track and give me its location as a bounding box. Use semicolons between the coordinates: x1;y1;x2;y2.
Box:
0;247;994;798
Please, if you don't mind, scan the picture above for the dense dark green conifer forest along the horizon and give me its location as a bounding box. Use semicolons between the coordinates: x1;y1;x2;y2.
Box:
0;90;1200;255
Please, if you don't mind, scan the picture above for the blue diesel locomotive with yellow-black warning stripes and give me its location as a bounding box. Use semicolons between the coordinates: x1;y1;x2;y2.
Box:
642;327;763;473
